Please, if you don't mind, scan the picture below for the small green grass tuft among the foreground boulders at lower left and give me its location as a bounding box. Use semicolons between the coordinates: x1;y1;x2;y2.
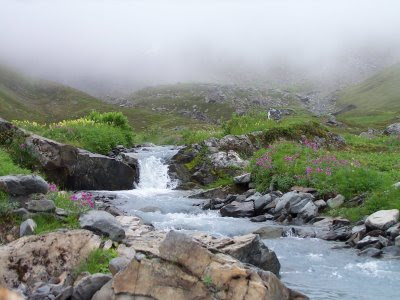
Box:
74;249;118;275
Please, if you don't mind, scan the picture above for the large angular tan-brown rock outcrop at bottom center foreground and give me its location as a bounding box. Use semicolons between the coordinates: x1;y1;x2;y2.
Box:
93;231;307;300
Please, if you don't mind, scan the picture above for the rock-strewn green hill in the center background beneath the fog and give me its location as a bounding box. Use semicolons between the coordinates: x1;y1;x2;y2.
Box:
126;83;310;123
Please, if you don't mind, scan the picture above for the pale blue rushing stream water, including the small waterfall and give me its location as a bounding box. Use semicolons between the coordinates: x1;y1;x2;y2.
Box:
108;147;400;300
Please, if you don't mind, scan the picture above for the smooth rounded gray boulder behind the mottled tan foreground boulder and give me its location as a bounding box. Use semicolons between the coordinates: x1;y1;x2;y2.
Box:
79;210;125;242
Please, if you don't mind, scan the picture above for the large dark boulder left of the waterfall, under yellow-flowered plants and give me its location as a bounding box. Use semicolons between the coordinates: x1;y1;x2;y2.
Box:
27;135;137;190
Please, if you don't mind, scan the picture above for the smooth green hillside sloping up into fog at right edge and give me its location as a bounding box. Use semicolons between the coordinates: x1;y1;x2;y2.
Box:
337;64;400;127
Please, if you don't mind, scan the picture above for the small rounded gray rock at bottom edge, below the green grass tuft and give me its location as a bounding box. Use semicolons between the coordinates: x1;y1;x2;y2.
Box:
72;273;112;300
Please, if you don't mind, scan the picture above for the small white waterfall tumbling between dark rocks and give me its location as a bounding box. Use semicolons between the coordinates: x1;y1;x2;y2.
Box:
136;147;178;190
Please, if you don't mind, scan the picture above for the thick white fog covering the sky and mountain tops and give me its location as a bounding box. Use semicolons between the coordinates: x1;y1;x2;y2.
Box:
0;0;400;95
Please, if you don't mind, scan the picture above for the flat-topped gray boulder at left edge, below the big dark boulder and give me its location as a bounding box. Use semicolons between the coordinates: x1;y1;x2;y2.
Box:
0;175;49;196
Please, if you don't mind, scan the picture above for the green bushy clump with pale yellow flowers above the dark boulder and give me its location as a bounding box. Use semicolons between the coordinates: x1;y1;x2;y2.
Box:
13;112;134;154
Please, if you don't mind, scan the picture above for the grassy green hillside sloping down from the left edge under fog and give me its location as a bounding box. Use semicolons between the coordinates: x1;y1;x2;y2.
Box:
0;67;204;131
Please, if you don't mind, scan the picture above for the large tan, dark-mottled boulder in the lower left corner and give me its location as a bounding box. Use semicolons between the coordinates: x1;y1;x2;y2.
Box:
0;230;101;288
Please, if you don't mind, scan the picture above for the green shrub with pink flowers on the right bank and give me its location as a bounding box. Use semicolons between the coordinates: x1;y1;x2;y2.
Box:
251;140;383;198
